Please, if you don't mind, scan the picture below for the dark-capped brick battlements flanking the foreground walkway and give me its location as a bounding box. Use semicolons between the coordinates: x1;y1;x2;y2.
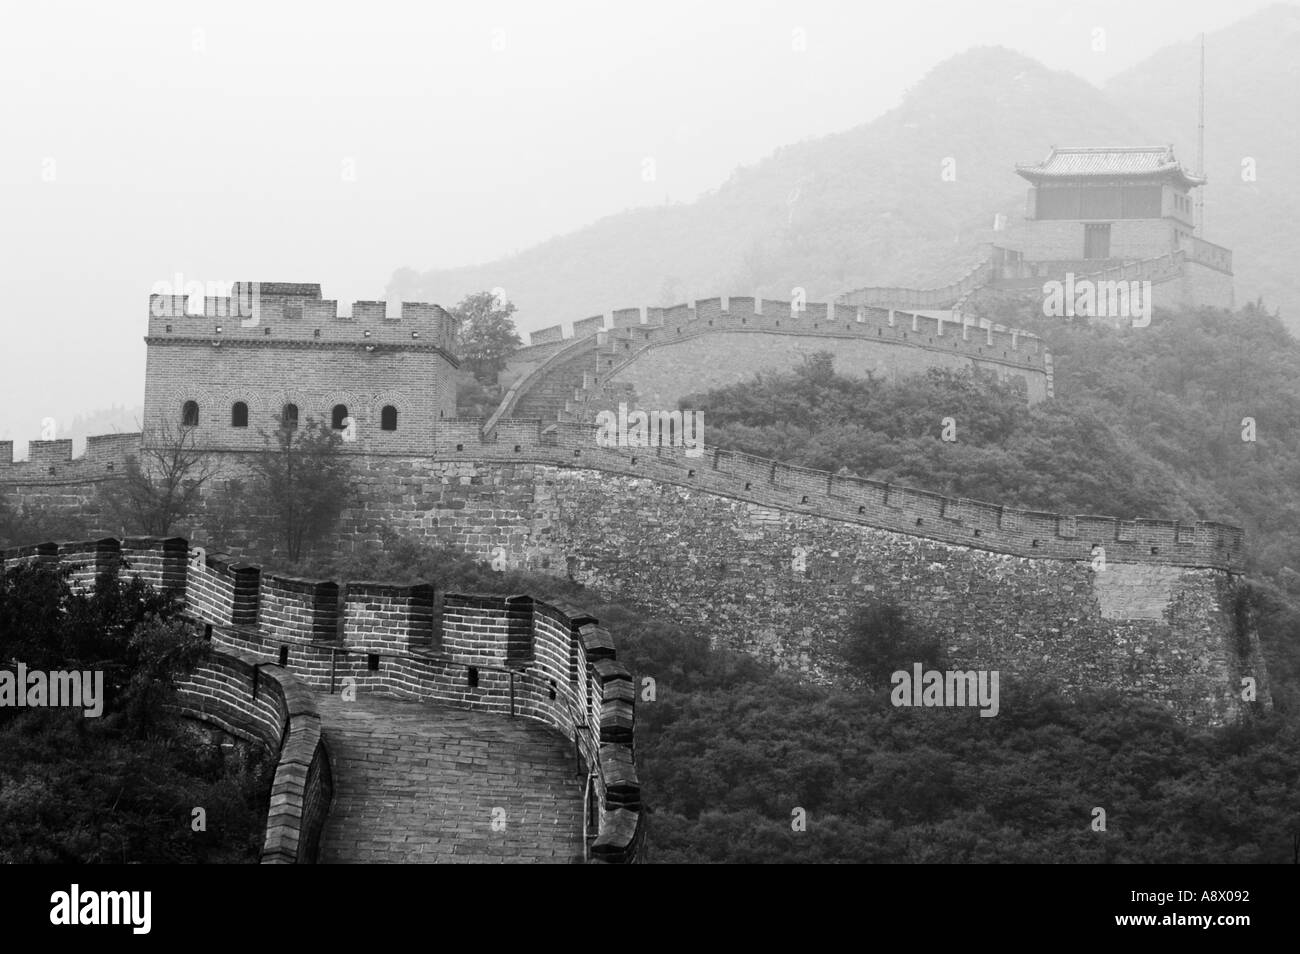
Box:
0;538;644;863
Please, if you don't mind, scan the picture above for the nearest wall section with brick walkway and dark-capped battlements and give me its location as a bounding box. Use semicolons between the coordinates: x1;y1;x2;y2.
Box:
0;538;644;863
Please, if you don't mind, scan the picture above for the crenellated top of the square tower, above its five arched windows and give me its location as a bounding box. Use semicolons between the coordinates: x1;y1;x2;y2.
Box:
146;282;459;354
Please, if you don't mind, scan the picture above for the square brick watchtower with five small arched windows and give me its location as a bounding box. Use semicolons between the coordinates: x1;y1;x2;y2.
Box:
144;282;459;454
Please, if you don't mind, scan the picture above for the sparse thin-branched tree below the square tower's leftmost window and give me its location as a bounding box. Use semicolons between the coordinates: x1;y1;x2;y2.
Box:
100;422;220;537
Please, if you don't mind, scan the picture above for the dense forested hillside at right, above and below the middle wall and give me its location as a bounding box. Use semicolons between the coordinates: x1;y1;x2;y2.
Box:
634;300;1300;862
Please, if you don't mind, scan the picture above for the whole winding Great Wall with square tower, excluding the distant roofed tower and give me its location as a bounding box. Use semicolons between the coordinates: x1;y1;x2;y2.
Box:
0;227;1271;862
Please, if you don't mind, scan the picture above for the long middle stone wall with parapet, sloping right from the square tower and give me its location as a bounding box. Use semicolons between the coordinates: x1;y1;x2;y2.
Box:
0;421;1268;724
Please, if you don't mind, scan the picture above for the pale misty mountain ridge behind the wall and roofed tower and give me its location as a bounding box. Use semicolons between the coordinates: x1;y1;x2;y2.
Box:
387;6;1300;330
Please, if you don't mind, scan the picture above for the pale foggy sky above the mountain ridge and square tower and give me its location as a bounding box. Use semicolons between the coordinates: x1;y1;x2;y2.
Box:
0;0;1268;454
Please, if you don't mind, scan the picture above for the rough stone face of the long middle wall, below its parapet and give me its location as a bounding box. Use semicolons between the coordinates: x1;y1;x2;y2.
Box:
223;441;1266;723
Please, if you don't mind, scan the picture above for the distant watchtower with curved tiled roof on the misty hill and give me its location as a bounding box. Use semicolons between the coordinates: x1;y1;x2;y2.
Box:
993;146;1232;308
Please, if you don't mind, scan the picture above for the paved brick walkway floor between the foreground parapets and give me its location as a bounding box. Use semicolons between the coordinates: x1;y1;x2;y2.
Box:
316;693;582;864
